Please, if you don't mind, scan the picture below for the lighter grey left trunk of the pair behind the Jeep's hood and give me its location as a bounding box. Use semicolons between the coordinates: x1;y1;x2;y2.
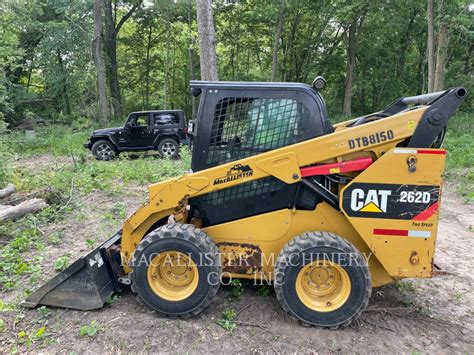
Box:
92;0;110;125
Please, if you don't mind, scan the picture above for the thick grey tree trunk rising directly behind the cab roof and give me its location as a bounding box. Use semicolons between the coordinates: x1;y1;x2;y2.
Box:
196;0;218;80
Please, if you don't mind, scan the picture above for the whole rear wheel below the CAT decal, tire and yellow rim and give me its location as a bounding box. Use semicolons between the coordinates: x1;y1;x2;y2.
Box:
274;232;372;328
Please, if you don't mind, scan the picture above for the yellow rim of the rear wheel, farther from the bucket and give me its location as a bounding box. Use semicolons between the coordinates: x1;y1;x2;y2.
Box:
296;260;351;312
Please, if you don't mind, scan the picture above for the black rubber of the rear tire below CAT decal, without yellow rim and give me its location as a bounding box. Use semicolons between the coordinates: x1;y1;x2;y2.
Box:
274;232;372;329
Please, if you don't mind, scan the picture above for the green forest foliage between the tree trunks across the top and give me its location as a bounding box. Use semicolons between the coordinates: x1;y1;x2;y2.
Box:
0;0;474;124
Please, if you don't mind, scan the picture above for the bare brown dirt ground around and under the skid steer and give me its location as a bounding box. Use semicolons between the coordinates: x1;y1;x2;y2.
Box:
0;160;474;353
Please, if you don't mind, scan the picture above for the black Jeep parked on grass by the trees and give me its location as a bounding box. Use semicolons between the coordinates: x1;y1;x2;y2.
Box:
84;110;188;160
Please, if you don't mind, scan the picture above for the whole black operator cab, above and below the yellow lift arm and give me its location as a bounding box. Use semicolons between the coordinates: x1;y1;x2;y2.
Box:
189;81;334;226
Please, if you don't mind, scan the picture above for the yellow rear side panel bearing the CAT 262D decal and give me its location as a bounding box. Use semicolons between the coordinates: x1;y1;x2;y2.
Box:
341;148;446;277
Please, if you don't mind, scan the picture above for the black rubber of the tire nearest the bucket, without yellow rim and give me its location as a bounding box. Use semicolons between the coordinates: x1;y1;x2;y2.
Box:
130;223;222;318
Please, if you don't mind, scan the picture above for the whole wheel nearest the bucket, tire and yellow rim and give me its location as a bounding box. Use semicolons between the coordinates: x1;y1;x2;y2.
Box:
130;223;222;318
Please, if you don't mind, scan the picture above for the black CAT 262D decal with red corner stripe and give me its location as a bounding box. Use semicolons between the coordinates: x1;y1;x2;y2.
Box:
342;183;439;220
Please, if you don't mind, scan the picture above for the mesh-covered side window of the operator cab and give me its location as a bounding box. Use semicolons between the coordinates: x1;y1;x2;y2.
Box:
206;98;309;166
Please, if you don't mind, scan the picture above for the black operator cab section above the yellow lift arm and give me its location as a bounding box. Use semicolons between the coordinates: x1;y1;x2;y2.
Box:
187;81;333;171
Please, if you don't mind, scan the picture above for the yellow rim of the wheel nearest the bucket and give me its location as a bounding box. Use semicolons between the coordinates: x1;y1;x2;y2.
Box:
147;251;199;302
